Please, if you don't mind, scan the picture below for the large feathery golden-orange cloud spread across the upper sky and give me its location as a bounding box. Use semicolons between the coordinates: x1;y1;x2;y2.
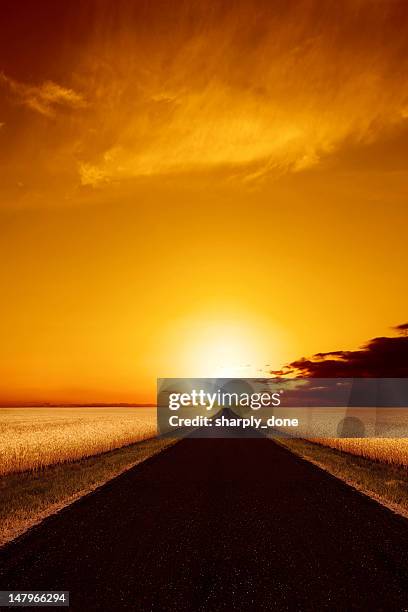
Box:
69;0;408;185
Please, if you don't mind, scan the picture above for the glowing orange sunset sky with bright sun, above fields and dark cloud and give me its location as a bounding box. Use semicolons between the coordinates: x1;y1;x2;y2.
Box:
0;0;408;402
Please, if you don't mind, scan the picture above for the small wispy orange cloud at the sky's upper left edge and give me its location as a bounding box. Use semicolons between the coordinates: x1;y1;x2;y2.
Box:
0;72;86;117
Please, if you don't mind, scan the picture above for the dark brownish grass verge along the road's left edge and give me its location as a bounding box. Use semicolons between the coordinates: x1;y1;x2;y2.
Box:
0;438;176;546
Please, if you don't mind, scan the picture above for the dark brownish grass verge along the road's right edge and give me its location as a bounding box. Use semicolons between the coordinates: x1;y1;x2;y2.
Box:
275;438;408;518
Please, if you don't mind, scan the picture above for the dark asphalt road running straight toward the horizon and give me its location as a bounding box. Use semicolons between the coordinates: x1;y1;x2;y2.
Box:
0;438;408;612
